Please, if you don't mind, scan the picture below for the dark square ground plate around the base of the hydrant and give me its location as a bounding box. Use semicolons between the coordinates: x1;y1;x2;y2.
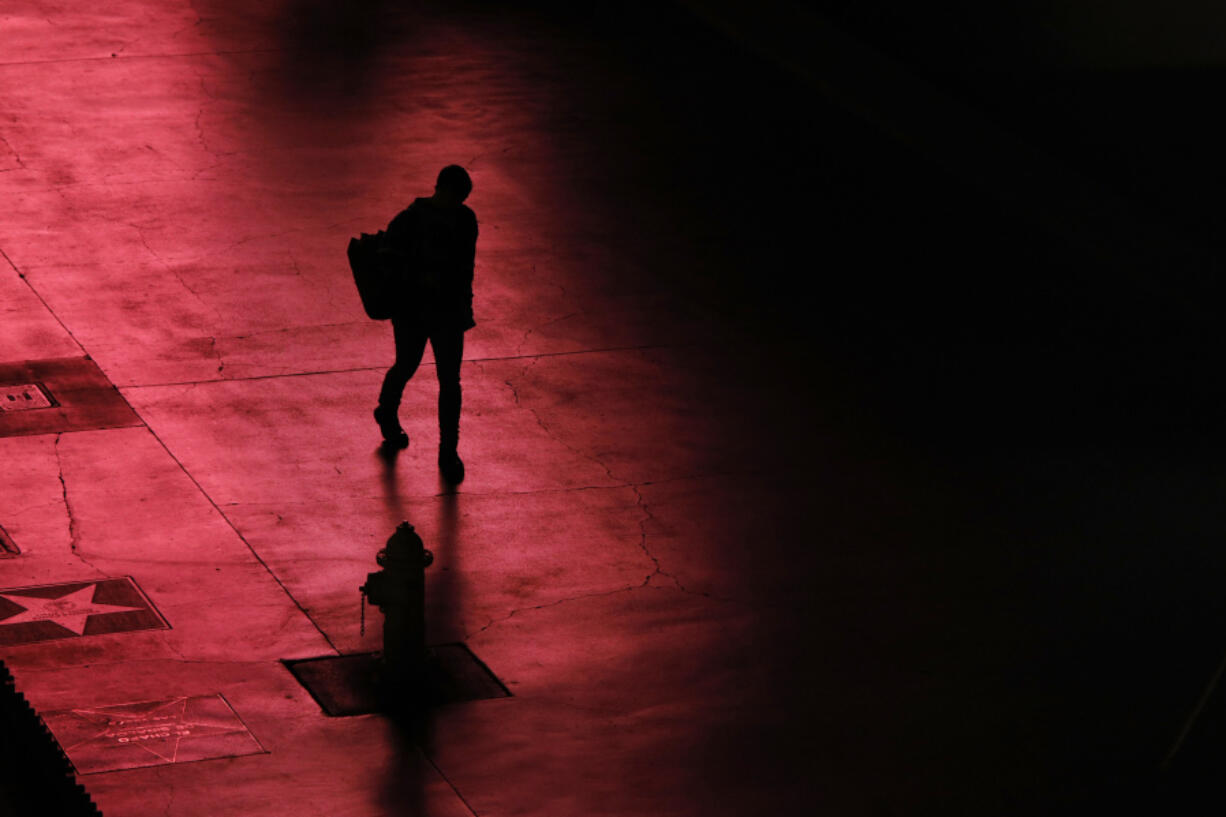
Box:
284;644;511;715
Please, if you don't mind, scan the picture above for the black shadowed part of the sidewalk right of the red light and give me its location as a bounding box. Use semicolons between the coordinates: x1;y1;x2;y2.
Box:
480;6;1226;815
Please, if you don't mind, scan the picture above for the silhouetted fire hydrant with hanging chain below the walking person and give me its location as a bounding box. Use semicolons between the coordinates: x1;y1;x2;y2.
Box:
359;521;434;698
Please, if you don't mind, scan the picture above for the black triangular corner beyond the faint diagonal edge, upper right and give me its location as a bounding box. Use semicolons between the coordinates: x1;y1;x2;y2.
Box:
810;0;1226;251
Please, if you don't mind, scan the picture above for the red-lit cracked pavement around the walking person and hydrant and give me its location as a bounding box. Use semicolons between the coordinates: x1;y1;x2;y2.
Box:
0;0;833;817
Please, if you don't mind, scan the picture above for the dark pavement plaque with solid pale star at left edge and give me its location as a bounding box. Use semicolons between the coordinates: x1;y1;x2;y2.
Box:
0;577;168;646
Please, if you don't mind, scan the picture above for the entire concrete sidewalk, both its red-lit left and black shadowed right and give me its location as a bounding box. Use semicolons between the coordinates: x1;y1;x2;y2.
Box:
0;0;1226;817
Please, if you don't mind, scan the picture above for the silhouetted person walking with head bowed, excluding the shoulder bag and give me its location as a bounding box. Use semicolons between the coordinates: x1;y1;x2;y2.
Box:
375;164;477;483
